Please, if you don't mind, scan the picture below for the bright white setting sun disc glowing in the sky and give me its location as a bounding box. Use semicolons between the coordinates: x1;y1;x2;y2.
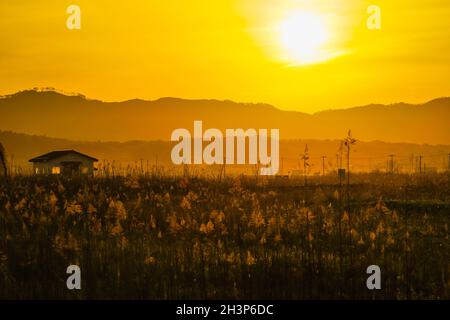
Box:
278;11;330;65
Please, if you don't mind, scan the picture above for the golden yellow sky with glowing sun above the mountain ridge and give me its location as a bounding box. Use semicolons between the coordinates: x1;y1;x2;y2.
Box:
0;0;450;113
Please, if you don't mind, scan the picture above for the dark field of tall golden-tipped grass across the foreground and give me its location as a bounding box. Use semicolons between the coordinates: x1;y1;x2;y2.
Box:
0;173;450;299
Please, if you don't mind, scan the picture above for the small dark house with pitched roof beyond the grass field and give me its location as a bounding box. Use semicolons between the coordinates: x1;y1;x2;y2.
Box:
29;150;98;176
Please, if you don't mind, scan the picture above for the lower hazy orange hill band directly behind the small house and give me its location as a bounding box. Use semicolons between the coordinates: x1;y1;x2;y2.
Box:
0;131;450;174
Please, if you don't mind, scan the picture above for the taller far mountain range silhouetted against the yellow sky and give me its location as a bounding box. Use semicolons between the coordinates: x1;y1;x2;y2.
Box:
0;90;450;144
